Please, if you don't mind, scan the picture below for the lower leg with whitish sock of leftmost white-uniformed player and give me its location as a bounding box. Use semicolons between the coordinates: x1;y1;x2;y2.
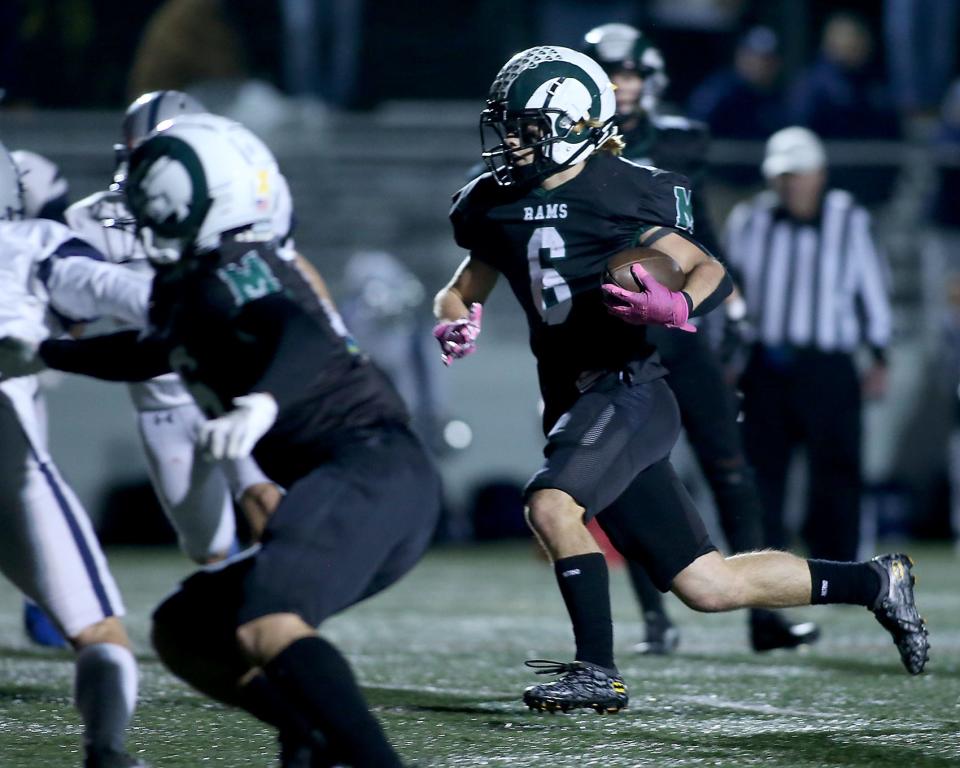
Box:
70;616;143;768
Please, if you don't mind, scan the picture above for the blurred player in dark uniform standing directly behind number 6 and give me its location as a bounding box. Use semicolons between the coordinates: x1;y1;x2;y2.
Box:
584;24;819;653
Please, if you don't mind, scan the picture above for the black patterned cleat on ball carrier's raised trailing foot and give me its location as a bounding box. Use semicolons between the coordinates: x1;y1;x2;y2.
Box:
870;554;930;675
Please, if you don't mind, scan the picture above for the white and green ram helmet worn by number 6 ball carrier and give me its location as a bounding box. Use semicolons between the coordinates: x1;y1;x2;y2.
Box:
480;45;617;186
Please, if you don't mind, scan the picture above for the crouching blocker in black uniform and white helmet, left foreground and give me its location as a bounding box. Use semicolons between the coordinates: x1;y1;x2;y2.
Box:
13;115;439;768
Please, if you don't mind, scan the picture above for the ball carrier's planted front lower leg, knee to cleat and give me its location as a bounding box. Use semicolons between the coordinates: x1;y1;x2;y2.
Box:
523;488;628;712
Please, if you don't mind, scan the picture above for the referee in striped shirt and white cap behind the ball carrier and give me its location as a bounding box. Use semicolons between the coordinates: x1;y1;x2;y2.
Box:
727;127;891;560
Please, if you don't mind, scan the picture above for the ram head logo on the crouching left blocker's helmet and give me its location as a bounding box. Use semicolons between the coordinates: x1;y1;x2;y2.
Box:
126;134;210;241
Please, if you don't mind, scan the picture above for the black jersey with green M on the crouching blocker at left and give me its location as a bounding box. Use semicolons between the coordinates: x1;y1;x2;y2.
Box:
42;242;407;485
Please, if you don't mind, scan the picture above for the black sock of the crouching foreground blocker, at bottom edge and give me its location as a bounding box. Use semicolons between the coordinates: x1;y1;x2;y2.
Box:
263;637;400;768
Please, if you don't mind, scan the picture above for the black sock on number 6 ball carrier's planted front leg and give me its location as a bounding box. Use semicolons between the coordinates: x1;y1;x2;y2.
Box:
553;552;616;669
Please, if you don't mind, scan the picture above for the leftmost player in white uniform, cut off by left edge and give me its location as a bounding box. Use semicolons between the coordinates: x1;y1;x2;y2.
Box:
0;145;150;768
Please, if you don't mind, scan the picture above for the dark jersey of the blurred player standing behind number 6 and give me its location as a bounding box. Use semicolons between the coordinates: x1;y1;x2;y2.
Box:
622;115;723;260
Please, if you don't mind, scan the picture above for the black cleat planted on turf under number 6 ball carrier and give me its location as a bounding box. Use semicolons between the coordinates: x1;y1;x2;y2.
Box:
523;659;629;715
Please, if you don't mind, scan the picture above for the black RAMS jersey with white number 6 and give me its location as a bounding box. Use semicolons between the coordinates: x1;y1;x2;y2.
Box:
450;153;693;427
